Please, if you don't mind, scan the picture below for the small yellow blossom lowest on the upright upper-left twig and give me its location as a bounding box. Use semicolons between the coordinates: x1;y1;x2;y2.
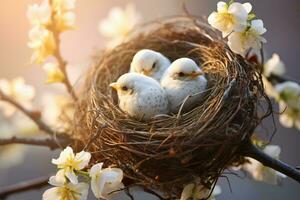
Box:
43;63;65;83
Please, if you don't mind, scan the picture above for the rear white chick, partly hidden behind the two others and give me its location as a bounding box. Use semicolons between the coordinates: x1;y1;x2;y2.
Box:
130;49;171;81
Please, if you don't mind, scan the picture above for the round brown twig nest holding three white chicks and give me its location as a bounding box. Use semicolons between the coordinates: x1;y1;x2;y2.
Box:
74;17;267;197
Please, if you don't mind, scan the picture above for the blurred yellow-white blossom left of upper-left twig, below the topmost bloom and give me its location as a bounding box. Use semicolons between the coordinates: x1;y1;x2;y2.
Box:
28;26;56;64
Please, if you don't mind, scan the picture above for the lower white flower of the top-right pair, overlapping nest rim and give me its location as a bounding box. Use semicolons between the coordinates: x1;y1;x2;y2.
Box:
228;19;267;56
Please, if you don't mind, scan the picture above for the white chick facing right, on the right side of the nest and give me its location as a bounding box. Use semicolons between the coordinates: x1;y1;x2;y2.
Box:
161;58;207;113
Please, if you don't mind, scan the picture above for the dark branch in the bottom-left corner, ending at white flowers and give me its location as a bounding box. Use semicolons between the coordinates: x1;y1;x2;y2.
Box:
0;176;50;199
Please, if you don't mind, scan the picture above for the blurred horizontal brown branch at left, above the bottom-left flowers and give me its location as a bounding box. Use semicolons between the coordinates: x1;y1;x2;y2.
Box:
0;137;70;150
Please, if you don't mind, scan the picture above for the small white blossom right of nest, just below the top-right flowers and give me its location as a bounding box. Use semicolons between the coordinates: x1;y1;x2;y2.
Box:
264;54;285;77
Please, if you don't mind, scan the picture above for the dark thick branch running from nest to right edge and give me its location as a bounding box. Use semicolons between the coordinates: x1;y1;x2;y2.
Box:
241;139;300;183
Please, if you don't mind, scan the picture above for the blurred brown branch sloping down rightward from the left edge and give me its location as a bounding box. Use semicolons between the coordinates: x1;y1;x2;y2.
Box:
0;90;55;136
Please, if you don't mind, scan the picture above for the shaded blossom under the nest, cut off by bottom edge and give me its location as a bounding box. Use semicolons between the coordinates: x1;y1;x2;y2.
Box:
180;180;222;200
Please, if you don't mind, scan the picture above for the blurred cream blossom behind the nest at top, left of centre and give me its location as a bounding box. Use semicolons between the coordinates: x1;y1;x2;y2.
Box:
99;4;140;47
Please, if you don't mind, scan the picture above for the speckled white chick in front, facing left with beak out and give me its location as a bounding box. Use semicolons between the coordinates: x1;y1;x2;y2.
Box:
110;73;169;120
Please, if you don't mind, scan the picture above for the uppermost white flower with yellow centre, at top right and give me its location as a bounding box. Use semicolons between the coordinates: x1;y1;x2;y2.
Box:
208;1;252;37
